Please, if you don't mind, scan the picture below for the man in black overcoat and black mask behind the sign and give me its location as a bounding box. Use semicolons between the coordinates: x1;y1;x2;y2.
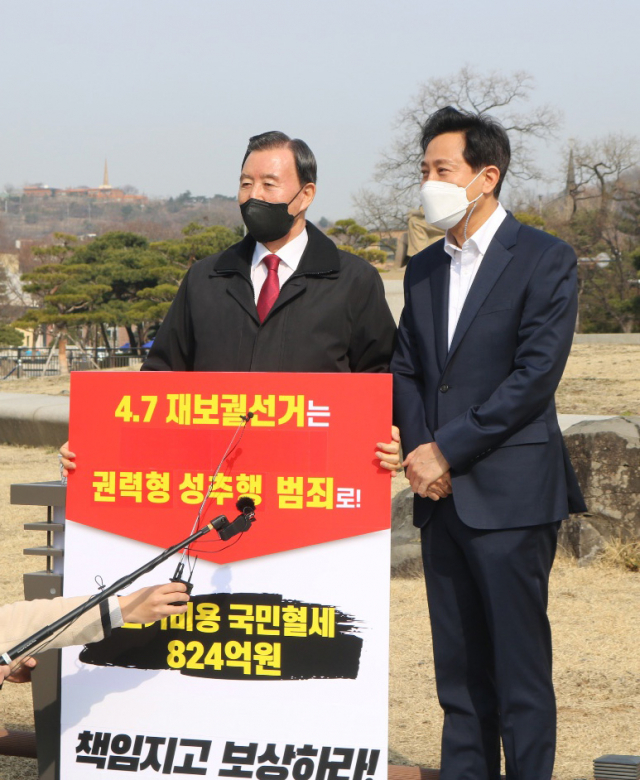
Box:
143;132;395;372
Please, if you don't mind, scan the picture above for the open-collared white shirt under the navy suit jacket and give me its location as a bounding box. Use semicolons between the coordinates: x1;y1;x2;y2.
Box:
444;203;507;347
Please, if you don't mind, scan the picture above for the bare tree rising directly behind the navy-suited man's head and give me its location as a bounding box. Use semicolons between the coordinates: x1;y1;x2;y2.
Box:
354;66;561;229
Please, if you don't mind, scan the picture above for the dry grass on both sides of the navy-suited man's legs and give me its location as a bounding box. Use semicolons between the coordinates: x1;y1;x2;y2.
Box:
389;556;640;780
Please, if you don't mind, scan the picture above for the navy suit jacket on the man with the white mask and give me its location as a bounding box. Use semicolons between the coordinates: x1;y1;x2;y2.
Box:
391;213;586;529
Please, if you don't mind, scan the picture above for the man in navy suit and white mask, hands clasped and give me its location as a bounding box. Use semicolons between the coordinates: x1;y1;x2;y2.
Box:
391;107;585;780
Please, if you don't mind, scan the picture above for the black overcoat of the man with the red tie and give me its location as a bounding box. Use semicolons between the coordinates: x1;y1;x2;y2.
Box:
142;223;396;372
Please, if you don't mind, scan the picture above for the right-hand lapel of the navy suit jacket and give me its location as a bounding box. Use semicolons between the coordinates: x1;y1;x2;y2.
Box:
445;212;520;366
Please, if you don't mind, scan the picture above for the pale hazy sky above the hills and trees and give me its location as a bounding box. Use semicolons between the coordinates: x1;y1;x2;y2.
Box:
0;0;640;219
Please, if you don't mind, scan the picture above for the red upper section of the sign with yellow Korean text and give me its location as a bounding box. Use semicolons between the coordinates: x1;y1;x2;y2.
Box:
67;372;391;563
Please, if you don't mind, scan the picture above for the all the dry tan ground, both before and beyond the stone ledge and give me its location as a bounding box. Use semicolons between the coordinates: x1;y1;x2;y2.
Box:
0;345;640;780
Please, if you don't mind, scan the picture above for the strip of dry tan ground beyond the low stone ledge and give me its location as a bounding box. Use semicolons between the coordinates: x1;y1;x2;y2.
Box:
0;344;640;415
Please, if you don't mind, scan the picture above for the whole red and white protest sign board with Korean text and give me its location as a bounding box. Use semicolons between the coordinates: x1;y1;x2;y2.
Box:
61;372;391;780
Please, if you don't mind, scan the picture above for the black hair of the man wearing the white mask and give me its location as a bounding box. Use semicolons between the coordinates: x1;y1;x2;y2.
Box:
420;106;511;197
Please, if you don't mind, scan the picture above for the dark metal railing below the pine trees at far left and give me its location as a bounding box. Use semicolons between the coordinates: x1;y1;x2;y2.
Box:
0;347;148;380
